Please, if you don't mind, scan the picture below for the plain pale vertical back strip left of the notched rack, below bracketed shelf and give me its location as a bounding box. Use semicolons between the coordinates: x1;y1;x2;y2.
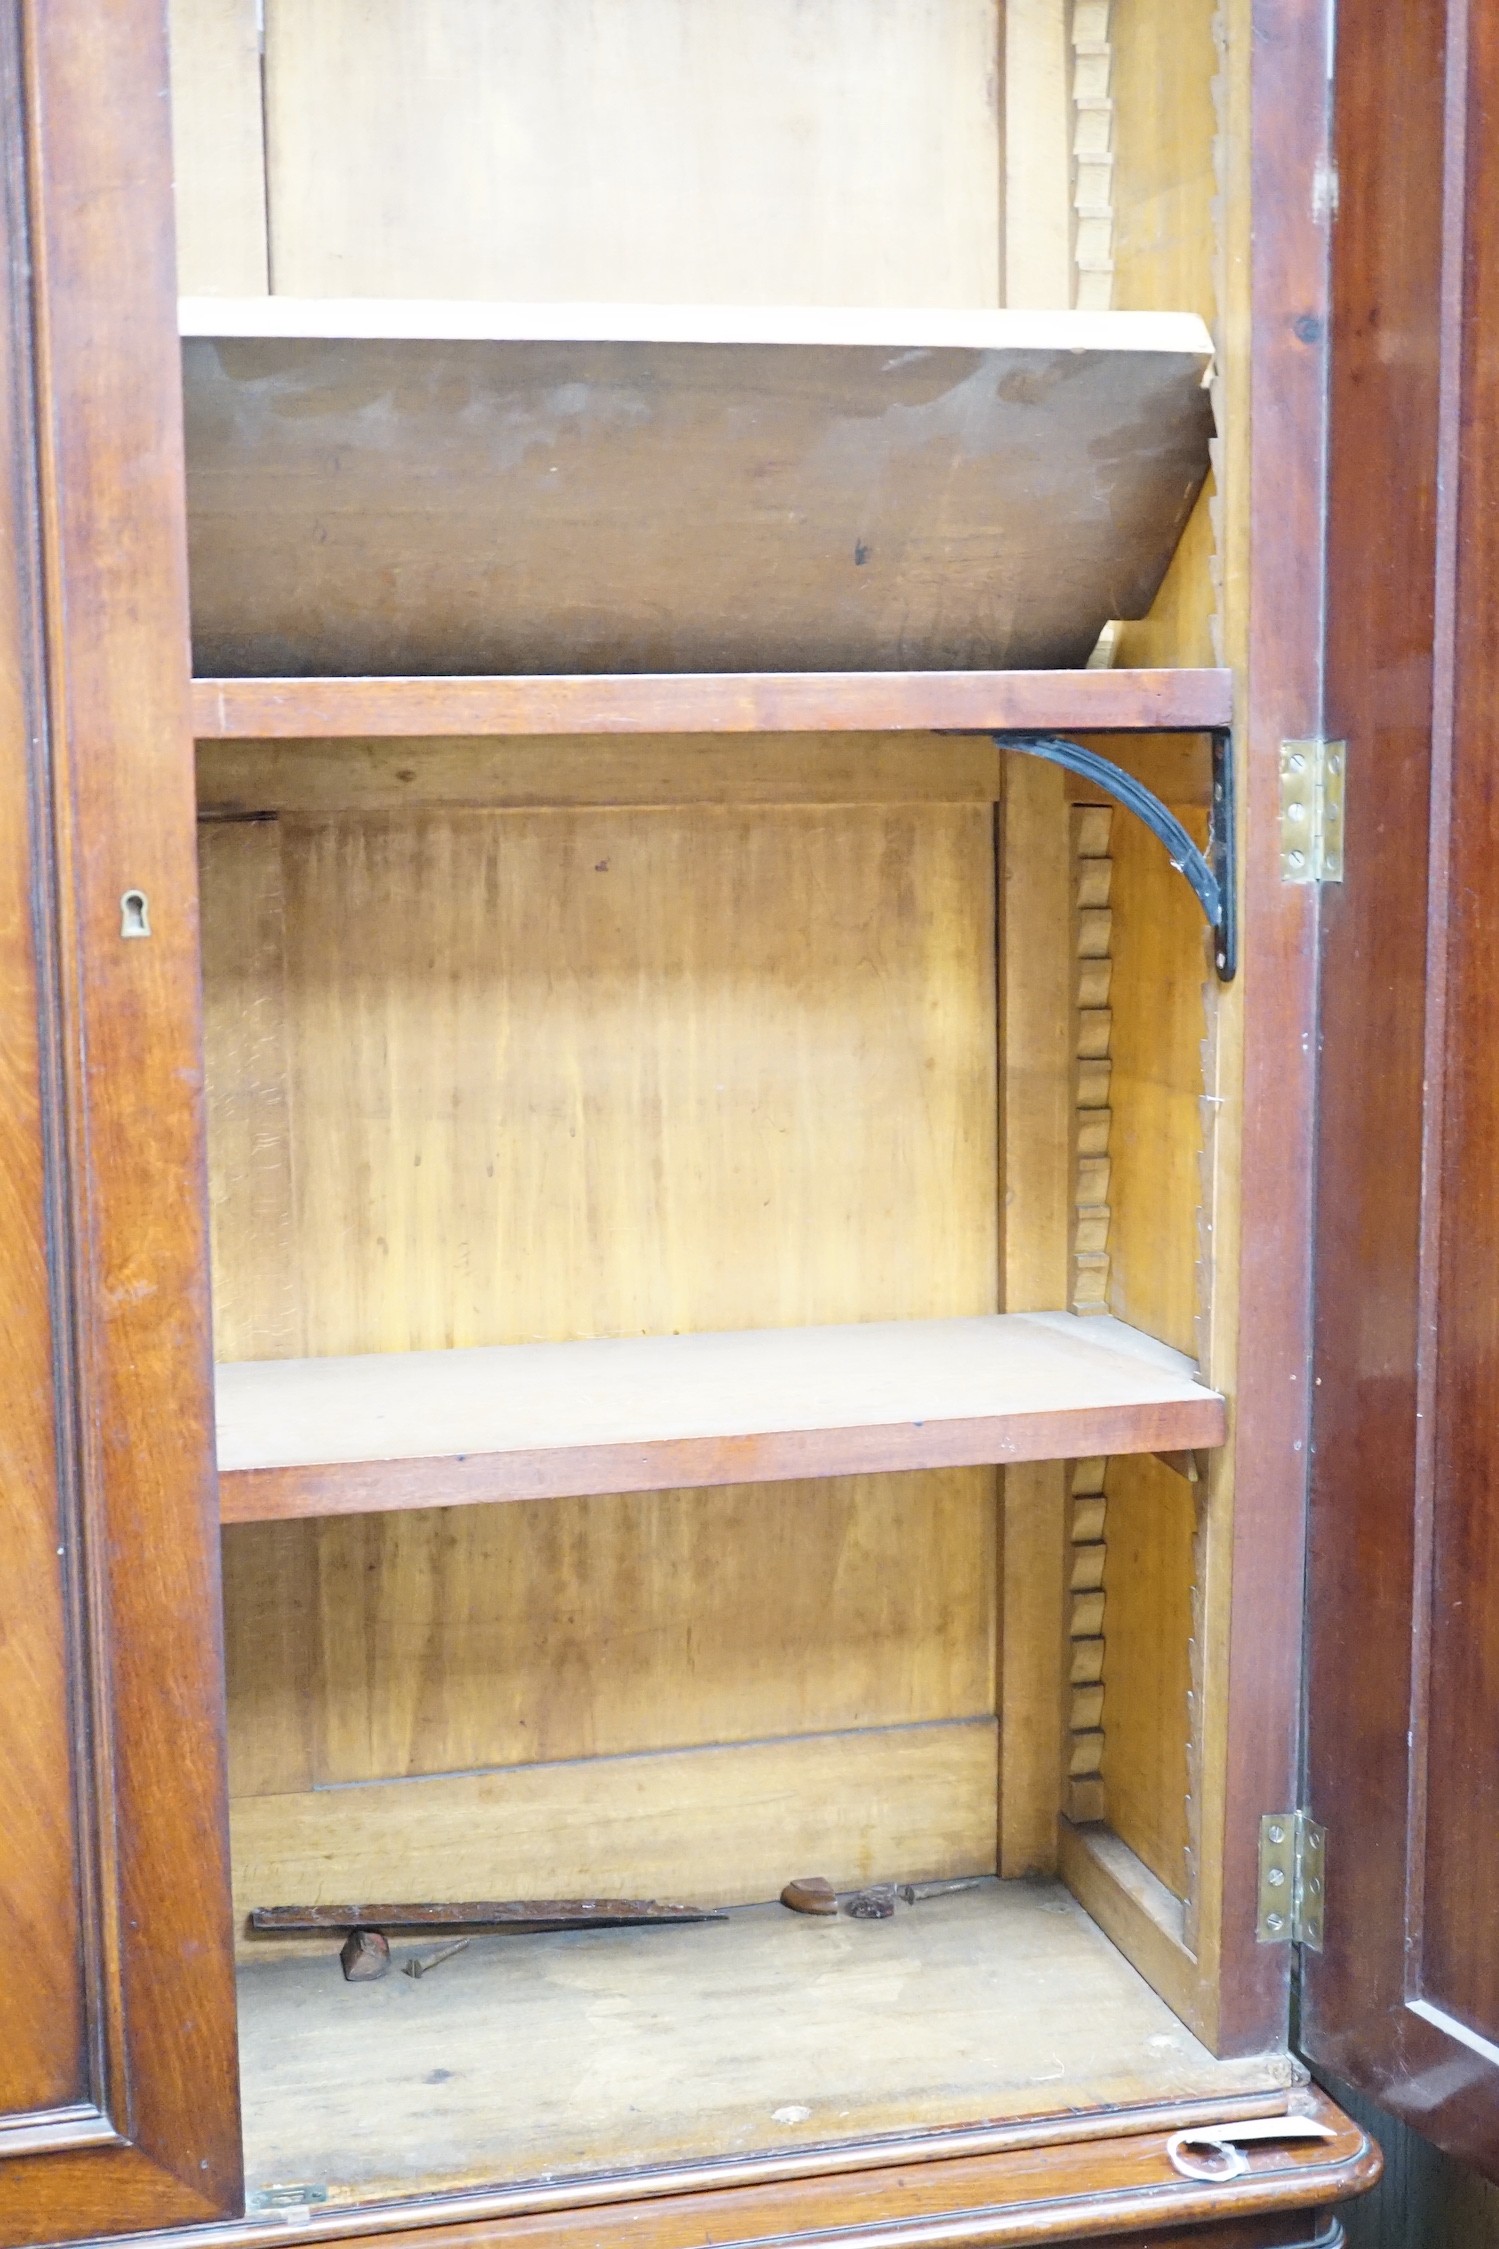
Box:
998;756;1076;1876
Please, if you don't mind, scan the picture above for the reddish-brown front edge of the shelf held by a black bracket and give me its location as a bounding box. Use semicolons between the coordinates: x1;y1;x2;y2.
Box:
193;670;1234;742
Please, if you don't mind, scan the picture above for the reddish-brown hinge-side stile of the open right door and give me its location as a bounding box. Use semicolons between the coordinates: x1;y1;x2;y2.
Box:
1303;0;1447;2107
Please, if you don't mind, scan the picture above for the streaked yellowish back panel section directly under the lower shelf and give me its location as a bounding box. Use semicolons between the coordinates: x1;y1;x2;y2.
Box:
225;1469;993;1790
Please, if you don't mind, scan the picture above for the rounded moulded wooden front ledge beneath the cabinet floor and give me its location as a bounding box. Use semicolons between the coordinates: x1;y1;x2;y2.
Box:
49;2092;1380;2249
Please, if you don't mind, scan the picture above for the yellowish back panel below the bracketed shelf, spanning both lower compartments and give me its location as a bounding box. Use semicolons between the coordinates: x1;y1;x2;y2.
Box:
202;791;998;1903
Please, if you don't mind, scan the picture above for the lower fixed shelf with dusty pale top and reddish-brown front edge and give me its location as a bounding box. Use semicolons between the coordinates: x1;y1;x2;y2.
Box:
218;1311;1225;1523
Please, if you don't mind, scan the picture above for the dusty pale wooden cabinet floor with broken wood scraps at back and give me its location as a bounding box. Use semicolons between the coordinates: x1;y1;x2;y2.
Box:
240;1869;1288;2204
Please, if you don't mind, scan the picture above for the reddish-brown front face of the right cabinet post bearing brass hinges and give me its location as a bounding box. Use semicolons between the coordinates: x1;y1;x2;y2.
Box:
1209;0;1328;2053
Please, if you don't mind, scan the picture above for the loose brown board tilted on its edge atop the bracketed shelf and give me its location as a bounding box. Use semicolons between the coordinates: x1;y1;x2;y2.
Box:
182;297;1211;677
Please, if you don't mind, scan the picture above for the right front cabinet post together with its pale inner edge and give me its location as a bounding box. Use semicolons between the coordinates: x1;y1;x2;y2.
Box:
1196;0;1326;2051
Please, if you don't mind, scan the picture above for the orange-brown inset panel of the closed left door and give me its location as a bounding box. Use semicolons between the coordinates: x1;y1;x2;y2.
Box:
0;11;96;2157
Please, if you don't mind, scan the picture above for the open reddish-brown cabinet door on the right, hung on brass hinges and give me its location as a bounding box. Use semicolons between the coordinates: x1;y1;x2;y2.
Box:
1301;0;1499;2175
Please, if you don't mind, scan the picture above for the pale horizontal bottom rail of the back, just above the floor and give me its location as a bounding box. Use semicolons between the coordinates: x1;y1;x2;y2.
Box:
231;1716;996;1916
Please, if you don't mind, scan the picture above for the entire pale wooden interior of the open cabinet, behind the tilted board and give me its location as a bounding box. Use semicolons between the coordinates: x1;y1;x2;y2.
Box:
173;0;1290;2204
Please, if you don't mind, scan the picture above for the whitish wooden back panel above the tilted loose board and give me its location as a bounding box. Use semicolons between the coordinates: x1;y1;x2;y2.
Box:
258;0;1006;306
